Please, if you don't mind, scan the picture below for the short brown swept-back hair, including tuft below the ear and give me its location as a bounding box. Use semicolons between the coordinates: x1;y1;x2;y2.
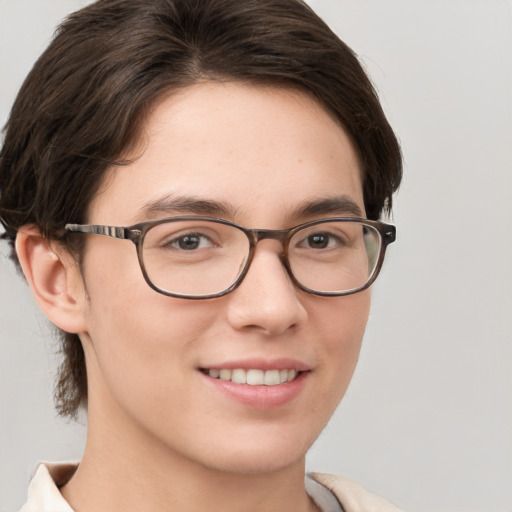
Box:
0;0;402;416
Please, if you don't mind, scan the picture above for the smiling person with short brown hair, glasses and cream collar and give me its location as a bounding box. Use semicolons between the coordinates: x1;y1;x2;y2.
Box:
0;0;402;512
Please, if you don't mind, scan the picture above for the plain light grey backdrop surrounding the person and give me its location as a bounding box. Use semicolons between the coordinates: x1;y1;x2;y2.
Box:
0;0;512;512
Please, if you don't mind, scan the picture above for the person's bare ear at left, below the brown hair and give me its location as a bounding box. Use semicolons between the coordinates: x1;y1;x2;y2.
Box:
16;225;87;334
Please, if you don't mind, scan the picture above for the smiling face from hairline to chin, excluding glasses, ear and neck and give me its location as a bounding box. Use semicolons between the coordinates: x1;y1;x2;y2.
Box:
76;83;369;473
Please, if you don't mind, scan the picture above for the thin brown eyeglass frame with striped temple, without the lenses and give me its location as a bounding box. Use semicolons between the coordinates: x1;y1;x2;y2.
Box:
64;215;396;300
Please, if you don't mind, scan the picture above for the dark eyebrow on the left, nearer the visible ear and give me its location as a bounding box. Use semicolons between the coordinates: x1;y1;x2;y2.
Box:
138;194;233;218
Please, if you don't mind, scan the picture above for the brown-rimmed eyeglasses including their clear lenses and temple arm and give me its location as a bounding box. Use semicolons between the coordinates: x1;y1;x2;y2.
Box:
65;216;396;299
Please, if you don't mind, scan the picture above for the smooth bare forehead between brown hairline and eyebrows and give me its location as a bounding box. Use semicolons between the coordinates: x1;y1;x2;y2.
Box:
89;82;364;224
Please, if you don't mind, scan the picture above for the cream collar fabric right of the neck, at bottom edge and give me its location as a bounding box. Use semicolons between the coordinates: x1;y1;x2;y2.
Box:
309;473;400;512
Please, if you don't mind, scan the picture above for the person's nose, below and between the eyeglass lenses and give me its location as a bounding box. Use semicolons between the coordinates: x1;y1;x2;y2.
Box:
227;240;307;336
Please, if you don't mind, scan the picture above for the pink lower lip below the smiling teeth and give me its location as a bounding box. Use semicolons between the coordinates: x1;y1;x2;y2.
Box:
203;372;309;409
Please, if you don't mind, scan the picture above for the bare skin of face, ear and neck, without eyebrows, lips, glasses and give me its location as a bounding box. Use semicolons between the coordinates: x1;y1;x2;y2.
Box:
18;83;370;512
